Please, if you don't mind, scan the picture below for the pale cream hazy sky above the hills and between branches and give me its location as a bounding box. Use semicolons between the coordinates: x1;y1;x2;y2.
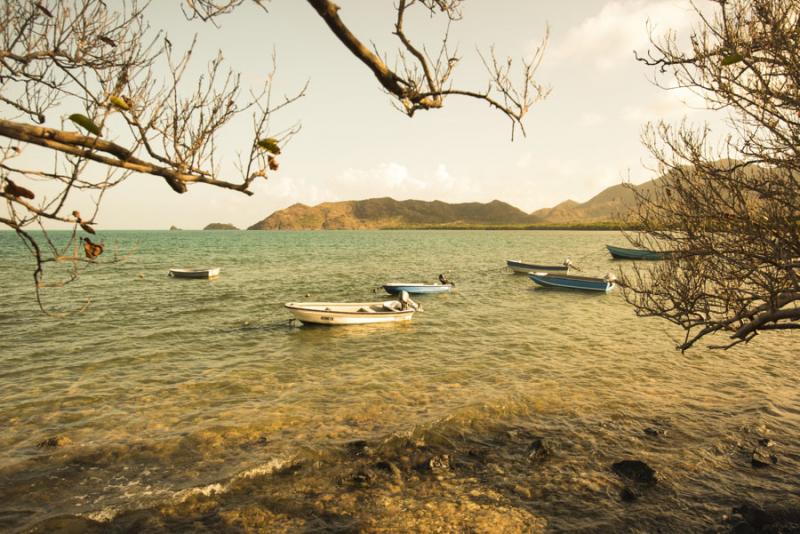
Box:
9;0;713;229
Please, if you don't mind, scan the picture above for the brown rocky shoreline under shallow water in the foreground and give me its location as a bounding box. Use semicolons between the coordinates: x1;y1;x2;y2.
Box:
20;426;800;533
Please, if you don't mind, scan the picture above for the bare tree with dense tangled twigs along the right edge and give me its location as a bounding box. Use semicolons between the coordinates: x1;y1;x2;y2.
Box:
622;0;800;350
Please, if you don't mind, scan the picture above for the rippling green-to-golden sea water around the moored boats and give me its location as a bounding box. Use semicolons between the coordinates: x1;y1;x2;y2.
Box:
0;231;800;531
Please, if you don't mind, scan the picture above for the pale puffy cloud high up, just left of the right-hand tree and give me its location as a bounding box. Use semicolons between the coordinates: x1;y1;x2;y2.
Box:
549;0;696;71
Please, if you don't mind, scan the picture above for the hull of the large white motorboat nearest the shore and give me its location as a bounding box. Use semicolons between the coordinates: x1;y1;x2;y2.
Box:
285;302;416;326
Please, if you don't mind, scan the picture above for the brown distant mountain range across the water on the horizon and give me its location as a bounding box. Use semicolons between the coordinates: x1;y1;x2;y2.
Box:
248;178;660;230
